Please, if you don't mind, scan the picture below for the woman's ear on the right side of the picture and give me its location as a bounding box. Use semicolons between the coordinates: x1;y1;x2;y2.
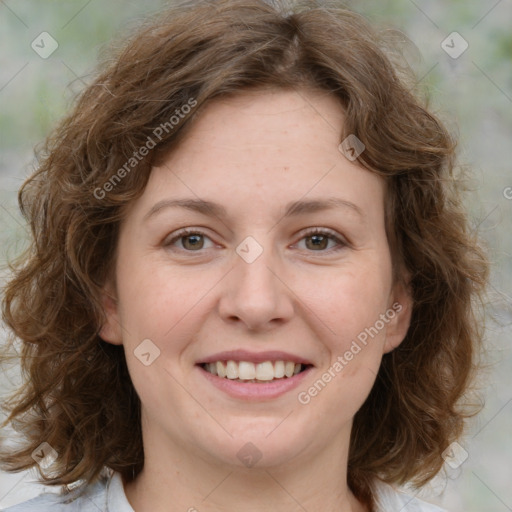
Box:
383;282;413;354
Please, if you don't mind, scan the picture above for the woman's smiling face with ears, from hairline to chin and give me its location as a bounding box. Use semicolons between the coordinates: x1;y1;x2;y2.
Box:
101;90;410;468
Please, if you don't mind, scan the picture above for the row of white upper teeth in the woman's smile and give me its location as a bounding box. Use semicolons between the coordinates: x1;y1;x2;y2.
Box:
204;361;303;382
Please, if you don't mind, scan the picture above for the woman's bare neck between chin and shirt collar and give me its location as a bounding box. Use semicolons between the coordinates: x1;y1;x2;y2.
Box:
125;420;368;512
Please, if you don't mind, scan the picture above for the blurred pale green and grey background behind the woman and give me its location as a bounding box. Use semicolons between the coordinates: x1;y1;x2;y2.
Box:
0;0;512;512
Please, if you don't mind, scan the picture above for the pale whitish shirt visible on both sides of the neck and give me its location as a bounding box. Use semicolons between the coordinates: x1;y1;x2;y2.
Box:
5;472;446;512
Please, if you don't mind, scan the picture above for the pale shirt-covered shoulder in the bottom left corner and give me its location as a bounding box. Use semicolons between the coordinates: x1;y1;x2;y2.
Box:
5;473;128;512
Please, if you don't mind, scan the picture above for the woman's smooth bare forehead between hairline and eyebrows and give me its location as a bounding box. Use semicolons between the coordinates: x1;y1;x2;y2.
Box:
127;89;383;224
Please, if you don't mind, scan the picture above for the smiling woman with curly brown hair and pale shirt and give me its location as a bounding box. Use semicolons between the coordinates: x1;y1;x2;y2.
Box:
2;0;487;512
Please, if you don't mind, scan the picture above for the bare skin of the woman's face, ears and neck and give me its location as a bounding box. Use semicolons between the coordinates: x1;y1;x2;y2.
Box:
101;89;411;512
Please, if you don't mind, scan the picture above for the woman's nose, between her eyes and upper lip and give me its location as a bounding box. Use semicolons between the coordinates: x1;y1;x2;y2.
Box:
219;240;294;331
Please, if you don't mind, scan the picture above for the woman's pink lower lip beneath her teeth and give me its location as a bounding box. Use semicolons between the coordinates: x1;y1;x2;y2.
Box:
197;366;313;400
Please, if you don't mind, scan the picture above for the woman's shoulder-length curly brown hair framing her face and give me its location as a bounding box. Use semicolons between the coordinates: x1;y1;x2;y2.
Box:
0;0;488;503
